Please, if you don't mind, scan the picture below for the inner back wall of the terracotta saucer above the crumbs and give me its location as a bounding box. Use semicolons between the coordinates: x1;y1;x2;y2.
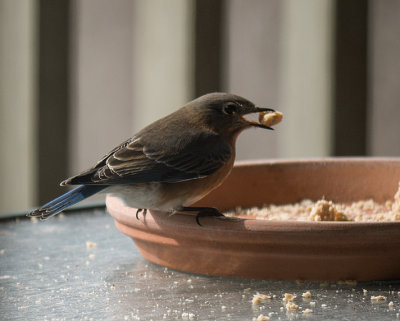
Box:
196;159;400;211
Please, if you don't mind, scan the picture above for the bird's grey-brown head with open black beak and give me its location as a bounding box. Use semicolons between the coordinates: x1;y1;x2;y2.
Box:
189;93;274;136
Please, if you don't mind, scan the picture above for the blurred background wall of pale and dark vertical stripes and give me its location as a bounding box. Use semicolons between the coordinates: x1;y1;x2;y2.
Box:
0;0;400;213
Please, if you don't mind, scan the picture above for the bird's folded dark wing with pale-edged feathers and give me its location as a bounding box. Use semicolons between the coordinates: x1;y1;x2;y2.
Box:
64;132;232;185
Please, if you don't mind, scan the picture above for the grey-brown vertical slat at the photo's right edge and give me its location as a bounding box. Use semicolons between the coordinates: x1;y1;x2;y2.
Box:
368;0;400;156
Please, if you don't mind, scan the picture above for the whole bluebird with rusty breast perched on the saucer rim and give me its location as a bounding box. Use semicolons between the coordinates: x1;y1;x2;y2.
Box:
27;93;274;223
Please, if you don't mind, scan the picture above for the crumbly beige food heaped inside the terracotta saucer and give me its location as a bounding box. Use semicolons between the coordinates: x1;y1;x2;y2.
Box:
225;183;400;222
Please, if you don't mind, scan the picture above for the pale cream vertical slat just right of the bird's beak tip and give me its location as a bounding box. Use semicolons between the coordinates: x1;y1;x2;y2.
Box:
279;0;334;157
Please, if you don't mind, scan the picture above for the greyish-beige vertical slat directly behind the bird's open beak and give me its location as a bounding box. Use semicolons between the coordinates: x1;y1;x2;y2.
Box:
222;0;286;160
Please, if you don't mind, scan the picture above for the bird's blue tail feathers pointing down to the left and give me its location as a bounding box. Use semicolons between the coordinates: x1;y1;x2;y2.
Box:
27;185;107;220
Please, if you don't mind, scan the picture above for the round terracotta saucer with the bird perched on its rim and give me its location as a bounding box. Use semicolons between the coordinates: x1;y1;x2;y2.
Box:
107;158;400;281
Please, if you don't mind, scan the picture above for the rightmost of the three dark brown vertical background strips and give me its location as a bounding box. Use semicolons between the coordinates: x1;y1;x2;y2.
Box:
332;0;368;156
